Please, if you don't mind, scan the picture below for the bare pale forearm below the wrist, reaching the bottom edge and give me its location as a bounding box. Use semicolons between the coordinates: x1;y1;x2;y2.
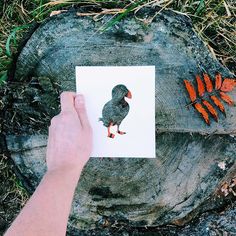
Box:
6;167;81;236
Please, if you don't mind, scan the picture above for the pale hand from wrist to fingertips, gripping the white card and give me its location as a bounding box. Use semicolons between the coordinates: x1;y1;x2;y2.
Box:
46;92;92;176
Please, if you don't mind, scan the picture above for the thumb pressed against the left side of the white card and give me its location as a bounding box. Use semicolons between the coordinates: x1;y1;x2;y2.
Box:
75;94;90;128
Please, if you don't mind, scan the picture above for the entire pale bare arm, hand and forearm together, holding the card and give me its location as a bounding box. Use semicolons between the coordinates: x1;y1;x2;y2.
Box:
5;92;92;236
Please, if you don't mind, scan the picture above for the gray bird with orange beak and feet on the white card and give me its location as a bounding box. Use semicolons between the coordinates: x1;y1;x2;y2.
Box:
99;84;132;138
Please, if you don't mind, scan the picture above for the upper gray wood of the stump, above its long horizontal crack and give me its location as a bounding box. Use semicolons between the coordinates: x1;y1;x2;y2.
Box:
16;9;236;134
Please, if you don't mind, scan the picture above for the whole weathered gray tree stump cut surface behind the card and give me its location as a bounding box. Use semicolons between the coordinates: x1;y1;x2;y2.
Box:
2;8;236;234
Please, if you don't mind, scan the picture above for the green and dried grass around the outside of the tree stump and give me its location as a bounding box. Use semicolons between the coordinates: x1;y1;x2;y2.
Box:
0;0;236;234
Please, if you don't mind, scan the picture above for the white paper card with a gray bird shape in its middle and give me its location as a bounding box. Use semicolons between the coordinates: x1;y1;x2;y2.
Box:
76;66;156;158
